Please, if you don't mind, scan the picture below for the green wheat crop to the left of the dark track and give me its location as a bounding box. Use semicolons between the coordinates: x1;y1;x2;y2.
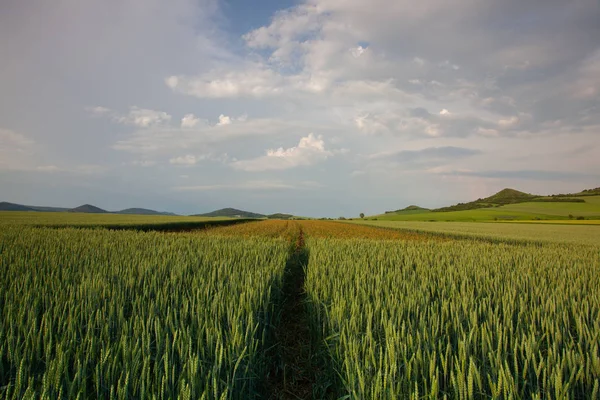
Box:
0;227;289;399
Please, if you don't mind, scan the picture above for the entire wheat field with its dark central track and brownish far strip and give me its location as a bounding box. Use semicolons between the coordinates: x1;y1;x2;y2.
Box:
0;213;600;399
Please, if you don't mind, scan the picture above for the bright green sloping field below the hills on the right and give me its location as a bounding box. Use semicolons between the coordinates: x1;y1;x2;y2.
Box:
370;196;600;222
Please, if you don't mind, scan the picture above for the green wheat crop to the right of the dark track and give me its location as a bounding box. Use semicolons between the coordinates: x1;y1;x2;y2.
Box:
306;239;600;399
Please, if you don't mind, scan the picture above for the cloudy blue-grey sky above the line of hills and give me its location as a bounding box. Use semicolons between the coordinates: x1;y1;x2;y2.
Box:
0;0;600;217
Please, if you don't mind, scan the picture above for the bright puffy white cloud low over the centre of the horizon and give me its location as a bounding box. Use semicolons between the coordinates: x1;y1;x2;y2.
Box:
231;133;333;172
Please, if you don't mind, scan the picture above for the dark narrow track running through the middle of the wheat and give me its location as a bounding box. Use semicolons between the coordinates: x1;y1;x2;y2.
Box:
265;233;332;400
